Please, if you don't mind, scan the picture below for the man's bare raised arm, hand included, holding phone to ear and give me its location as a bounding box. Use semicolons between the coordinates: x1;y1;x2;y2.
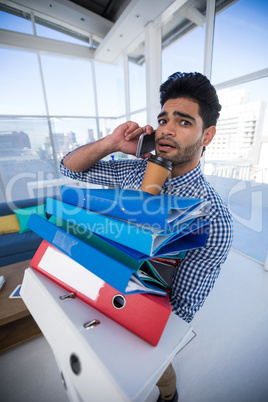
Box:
63;121;153;172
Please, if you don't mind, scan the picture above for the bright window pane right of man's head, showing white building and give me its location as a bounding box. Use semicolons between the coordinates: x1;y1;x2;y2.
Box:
205;78;268;183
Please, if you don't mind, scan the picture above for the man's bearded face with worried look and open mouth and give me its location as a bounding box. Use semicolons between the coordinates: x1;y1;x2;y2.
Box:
155;98;203;171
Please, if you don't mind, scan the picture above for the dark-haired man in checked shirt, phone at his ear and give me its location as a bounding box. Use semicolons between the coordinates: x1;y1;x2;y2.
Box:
61;73;233;402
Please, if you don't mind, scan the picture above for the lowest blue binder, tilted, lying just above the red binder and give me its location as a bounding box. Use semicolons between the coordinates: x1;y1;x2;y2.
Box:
27;214;166;296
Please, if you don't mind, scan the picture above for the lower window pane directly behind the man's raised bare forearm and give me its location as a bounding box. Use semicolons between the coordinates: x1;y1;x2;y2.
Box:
49;118;97;166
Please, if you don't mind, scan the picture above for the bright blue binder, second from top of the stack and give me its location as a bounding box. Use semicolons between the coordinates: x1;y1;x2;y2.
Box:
46;196;209;261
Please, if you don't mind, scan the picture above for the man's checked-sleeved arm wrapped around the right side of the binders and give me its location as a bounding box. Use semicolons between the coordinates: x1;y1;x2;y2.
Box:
170;214;233;322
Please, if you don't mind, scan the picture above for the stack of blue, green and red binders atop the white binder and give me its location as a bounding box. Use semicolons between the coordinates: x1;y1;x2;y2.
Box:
27;187;209;346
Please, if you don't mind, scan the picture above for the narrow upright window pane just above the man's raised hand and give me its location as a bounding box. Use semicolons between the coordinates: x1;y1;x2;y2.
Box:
128;61;146;112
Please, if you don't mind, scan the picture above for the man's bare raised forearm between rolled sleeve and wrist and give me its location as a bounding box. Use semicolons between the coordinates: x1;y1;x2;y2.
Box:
63;136;117;172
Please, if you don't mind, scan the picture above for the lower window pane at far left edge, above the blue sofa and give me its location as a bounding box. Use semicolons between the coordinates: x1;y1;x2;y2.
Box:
0;118;57;202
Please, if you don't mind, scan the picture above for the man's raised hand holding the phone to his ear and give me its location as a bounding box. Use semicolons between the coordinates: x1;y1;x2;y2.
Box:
111;121;153;155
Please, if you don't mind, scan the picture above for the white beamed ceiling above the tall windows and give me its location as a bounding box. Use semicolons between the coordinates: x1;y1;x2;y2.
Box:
0;0;234;64
